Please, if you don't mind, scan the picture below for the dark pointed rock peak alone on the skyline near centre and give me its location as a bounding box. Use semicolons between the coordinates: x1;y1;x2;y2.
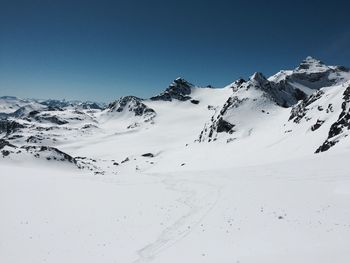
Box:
151;78;193;101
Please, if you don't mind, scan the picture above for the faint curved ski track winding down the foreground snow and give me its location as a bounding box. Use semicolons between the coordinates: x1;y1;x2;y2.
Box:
71;170;222;263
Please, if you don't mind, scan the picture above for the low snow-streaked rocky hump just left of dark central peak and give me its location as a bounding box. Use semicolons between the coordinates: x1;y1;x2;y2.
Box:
108;96;156;116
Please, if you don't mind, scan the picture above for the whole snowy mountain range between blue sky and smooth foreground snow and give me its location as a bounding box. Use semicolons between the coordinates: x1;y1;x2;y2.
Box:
0;57;350;172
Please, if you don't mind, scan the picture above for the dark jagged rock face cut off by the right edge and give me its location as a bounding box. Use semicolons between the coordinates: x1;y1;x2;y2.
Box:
316;86;350;153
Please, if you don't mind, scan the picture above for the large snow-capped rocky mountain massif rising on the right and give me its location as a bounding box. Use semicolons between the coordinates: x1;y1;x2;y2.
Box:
199;57;350;156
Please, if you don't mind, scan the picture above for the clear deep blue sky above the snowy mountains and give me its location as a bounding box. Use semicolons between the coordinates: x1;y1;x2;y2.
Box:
0;0;350;102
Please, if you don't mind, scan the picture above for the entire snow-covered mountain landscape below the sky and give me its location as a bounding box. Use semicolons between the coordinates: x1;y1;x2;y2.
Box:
0;57;350;263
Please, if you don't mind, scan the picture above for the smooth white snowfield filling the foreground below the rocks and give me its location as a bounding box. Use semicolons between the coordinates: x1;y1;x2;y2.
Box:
0;153;350;262
